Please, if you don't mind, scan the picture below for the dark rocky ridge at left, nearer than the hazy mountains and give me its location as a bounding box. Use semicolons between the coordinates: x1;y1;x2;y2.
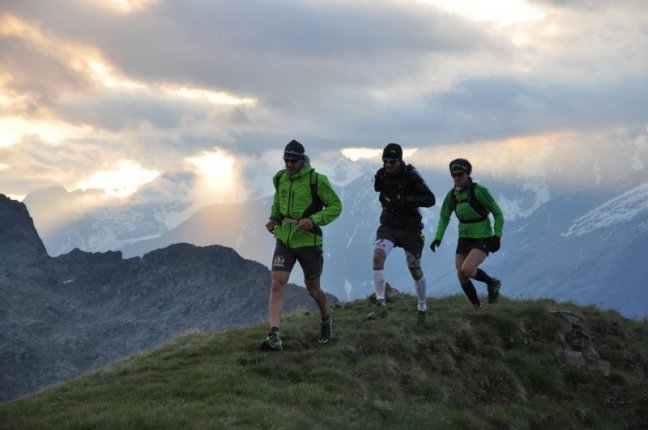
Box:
0;194;337;401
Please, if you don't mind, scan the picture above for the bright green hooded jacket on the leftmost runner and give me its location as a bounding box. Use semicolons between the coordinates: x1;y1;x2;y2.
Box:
270;165;342;248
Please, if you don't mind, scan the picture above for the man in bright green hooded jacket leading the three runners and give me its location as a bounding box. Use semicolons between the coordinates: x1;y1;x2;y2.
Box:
261;140;342;351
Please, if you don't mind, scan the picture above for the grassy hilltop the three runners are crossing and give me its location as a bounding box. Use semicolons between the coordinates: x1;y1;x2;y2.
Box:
0;296;648;430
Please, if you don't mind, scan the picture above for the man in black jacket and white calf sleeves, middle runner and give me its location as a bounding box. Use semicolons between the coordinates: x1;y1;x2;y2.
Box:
367;143;435;325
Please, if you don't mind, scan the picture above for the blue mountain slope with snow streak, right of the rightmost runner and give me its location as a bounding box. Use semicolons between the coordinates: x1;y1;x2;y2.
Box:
484;166;648;317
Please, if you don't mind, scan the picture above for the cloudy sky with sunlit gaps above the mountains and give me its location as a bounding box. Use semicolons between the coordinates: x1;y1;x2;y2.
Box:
0;0;648;207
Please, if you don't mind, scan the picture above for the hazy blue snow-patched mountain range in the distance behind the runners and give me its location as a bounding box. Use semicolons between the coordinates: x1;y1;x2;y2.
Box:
21;135;648;317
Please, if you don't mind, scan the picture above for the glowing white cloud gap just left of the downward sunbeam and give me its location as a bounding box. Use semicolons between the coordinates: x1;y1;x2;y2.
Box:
76;160;160;197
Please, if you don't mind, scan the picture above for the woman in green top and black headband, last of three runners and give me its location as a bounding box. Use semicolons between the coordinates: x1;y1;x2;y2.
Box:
430;158;504;307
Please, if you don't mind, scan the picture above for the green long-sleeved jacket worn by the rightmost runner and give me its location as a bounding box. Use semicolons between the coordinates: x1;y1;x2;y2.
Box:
434;184;504;240
